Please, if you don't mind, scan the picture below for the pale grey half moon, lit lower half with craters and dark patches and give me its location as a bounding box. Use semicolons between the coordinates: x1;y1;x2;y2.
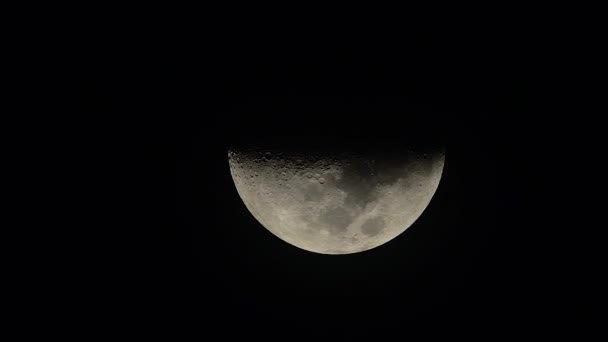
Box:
228;148;445;254
